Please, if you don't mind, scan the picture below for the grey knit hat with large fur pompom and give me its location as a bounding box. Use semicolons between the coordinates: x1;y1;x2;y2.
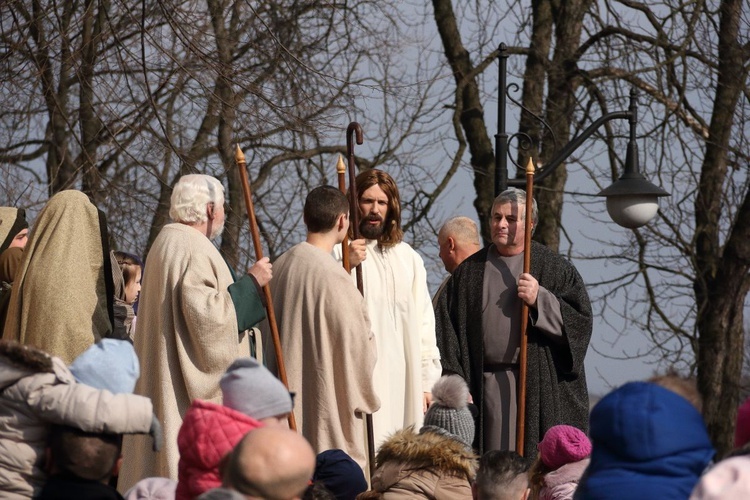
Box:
419;375;475;448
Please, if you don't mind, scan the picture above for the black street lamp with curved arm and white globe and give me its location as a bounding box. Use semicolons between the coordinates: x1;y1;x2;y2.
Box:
495;43;669;229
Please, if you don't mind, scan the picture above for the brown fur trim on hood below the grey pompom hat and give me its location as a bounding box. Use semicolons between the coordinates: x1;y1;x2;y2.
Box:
375;426;477;481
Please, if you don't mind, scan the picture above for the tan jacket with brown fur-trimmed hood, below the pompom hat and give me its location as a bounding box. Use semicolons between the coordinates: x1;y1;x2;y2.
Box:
357;427;478;500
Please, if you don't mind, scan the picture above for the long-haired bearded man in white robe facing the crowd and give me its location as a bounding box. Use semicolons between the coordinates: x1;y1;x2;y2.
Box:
337;169;441;448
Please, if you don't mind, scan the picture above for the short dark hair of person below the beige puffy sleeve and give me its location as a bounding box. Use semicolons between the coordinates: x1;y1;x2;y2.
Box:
49;425;122;482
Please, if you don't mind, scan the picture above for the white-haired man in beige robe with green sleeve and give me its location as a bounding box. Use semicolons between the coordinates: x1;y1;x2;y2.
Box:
118;175;271;491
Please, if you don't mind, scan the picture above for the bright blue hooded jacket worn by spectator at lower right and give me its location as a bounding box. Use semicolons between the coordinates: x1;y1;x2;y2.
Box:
575;382;714;499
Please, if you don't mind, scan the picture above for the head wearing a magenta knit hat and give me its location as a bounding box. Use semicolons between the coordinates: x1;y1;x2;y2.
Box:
529;425;591;498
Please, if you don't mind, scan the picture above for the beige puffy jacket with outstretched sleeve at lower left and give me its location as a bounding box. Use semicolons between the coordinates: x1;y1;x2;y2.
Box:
0;341;153;498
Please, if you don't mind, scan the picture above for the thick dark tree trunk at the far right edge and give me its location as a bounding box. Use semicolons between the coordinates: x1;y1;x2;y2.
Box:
694;0;750;454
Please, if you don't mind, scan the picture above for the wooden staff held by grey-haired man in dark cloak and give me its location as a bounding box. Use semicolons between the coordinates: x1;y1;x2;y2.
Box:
516;158;534;456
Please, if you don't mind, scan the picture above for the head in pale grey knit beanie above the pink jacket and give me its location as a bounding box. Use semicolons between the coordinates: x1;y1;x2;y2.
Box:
219;358;292;426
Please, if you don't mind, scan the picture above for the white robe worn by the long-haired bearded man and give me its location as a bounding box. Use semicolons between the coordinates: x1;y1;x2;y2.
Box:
334;240;441;448
